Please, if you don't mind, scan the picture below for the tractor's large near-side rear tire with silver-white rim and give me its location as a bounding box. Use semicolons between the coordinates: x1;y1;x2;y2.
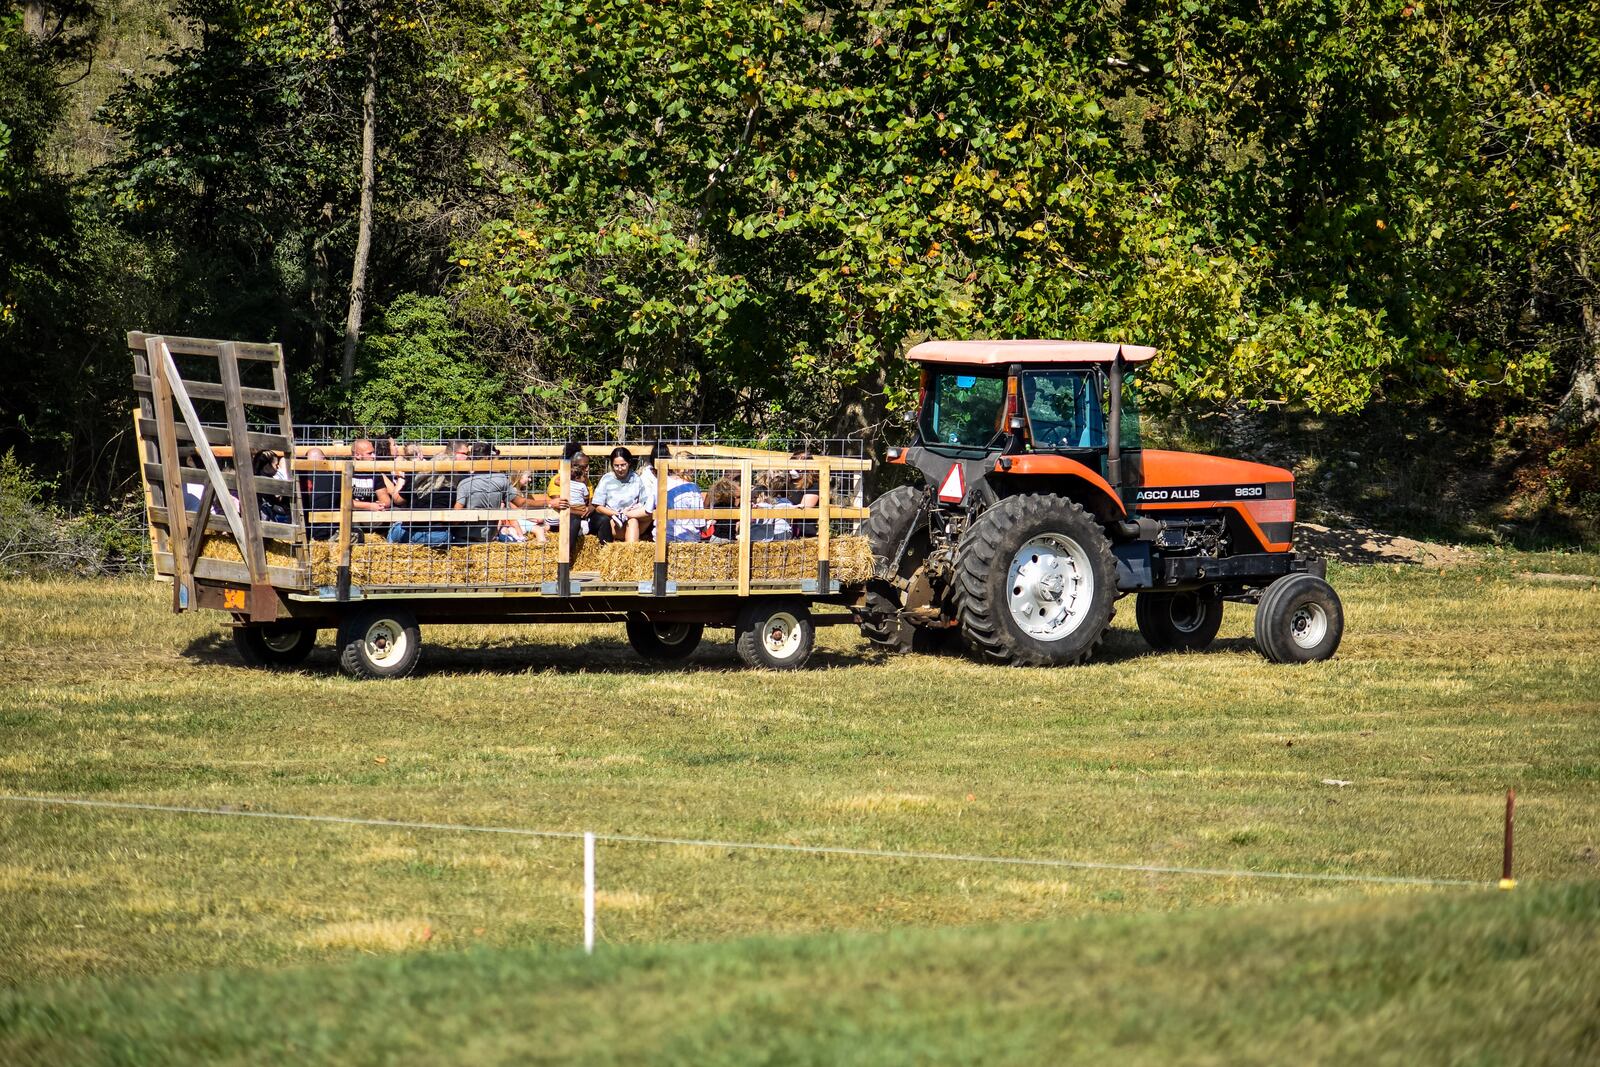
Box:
955;494;1117;667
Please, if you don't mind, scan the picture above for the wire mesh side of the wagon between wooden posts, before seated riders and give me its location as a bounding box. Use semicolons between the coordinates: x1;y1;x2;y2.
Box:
294;427;870;597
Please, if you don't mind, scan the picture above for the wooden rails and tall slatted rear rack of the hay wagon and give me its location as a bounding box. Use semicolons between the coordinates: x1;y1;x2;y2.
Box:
128;331;872;621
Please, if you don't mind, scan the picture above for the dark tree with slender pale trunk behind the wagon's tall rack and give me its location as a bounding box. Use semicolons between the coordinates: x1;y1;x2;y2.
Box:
109;0;472;408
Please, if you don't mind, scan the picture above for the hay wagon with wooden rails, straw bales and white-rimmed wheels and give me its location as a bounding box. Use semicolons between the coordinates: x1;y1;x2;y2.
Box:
128;333;872;678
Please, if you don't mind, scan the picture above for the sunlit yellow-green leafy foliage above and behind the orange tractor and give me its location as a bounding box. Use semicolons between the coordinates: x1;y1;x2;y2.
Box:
461;0;1595;428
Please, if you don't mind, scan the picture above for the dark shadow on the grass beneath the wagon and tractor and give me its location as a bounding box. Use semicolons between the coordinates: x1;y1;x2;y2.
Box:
181;624;1254;678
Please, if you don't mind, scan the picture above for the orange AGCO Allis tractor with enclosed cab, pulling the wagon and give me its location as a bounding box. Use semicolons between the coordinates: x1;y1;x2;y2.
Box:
858;341;1344;665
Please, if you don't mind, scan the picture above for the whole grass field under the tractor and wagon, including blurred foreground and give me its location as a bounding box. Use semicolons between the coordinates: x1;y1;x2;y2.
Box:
0;553;1600;1062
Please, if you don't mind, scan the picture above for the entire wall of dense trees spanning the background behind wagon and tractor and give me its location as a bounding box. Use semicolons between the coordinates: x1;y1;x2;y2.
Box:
0;0;1600;505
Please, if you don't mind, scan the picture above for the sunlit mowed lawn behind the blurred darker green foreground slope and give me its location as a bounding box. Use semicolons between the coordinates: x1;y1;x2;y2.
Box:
0;555;1600;1062
